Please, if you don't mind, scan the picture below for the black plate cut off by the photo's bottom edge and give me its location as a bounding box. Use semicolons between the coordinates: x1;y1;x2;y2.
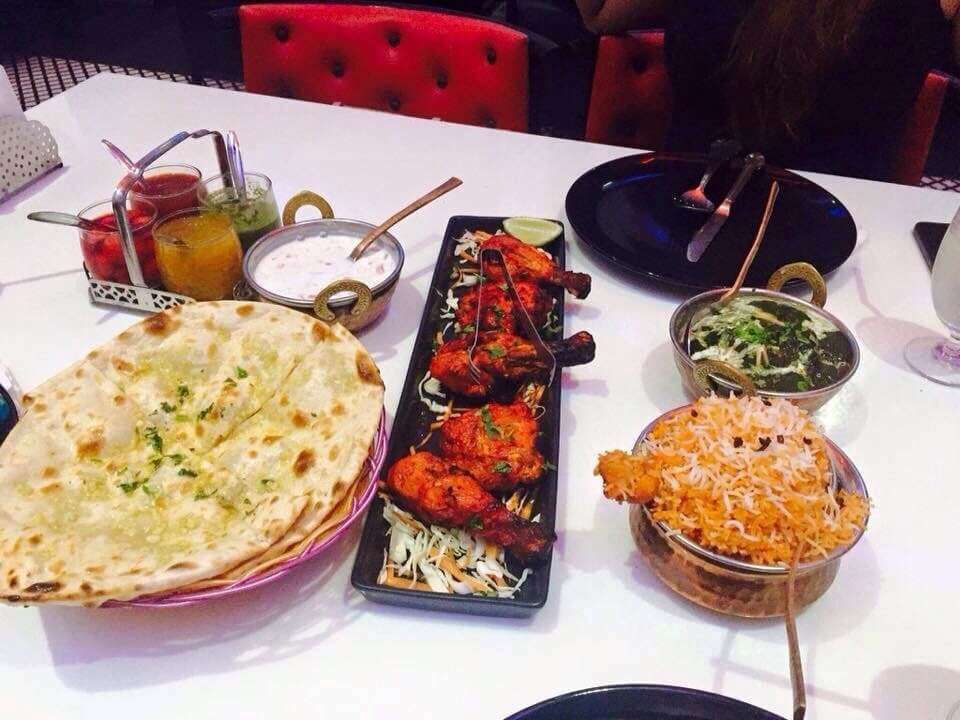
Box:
507;685;783;720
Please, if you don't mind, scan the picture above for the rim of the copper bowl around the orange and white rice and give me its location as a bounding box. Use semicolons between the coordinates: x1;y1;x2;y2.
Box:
633;403;870;577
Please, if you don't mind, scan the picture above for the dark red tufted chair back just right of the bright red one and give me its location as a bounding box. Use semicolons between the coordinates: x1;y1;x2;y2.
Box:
586;30;672;149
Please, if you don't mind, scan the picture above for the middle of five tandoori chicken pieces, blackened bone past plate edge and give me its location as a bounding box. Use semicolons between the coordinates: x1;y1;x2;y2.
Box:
430;332;596;398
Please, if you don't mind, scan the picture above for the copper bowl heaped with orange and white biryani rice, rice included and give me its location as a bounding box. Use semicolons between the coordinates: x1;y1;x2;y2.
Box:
596;395;870;617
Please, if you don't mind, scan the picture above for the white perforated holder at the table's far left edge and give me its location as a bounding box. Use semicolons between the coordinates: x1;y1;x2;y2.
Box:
0;115;63;202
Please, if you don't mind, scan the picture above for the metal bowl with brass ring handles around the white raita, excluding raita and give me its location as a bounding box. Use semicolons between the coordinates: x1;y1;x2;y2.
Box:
244;191;404;331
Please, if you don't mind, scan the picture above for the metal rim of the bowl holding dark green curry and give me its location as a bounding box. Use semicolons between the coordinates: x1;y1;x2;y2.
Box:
669;288;860;403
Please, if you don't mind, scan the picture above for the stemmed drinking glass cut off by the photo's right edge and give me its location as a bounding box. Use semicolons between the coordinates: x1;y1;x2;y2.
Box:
904;204;960;387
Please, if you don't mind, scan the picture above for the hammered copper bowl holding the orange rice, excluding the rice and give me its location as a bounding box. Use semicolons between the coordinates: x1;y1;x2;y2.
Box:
630;405;869;618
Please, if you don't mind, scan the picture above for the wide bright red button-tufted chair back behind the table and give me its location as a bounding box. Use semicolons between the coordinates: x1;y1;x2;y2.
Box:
239;5;529;130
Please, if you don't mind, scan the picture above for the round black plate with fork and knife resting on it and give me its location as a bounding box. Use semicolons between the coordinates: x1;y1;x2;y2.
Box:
567;153;857;290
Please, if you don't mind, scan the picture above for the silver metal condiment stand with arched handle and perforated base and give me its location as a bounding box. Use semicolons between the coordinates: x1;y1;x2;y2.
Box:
83;130;233;312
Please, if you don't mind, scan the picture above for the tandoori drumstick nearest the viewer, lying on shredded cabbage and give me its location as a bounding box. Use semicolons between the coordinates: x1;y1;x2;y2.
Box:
387;452;556;562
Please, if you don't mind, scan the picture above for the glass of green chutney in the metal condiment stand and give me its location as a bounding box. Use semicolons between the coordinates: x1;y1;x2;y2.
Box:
200;173;280;252
